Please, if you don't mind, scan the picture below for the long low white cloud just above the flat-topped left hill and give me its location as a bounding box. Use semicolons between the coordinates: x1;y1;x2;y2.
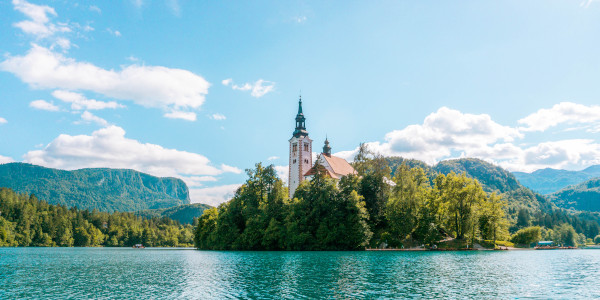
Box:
23;125;237;177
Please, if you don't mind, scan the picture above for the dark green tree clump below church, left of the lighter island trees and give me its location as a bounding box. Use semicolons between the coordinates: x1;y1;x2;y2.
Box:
195;164;370;250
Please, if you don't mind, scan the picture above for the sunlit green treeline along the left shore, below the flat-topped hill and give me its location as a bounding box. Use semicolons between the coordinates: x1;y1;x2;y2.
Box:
0;188;193;247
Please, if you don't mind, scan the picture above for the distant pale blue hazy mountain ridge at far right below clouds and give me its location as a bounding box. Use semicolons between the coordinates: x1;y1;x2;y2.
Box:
513;165;600;195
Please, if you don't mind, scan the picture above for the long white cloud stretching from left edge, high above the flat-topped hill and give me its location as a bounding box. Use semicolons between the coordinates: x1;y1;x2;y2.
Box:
0;44;210;116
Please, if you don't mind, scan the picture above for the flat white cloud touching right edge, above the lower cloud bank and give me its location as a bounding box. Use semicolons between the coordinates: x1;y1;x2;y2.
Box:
519;102;600;131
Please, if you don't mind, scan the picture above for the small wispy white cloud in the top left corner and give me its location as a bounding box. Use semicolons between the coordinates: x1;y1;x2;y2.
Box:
12;0;71;39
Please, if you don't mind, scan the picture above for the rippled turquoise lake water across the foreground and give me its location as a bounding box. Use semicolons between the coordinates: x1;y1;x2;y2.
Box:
0;248;600;299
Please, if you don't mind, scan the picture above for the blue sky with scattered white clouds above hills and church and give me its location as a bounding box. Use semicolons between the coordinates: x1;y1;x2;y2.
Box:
0;0;600;205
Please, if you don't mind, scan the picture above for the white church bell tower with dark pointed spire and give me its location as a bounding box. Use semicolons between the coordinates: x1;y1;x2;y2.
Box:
288;96;312;198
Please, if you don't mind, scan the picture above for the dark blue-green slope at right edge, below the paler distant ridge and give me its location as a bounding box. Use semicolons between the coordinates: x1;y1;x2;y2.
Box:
548;178;600;212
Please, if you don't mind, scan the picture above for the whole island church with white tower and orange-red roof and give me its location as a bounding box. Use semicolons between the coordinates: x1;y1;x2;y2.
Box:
289;97;357;198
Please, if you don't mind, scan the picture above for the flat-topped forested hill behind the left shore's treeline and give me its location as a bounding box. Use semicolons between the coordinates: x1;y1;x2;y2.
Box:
0;163;190;212
